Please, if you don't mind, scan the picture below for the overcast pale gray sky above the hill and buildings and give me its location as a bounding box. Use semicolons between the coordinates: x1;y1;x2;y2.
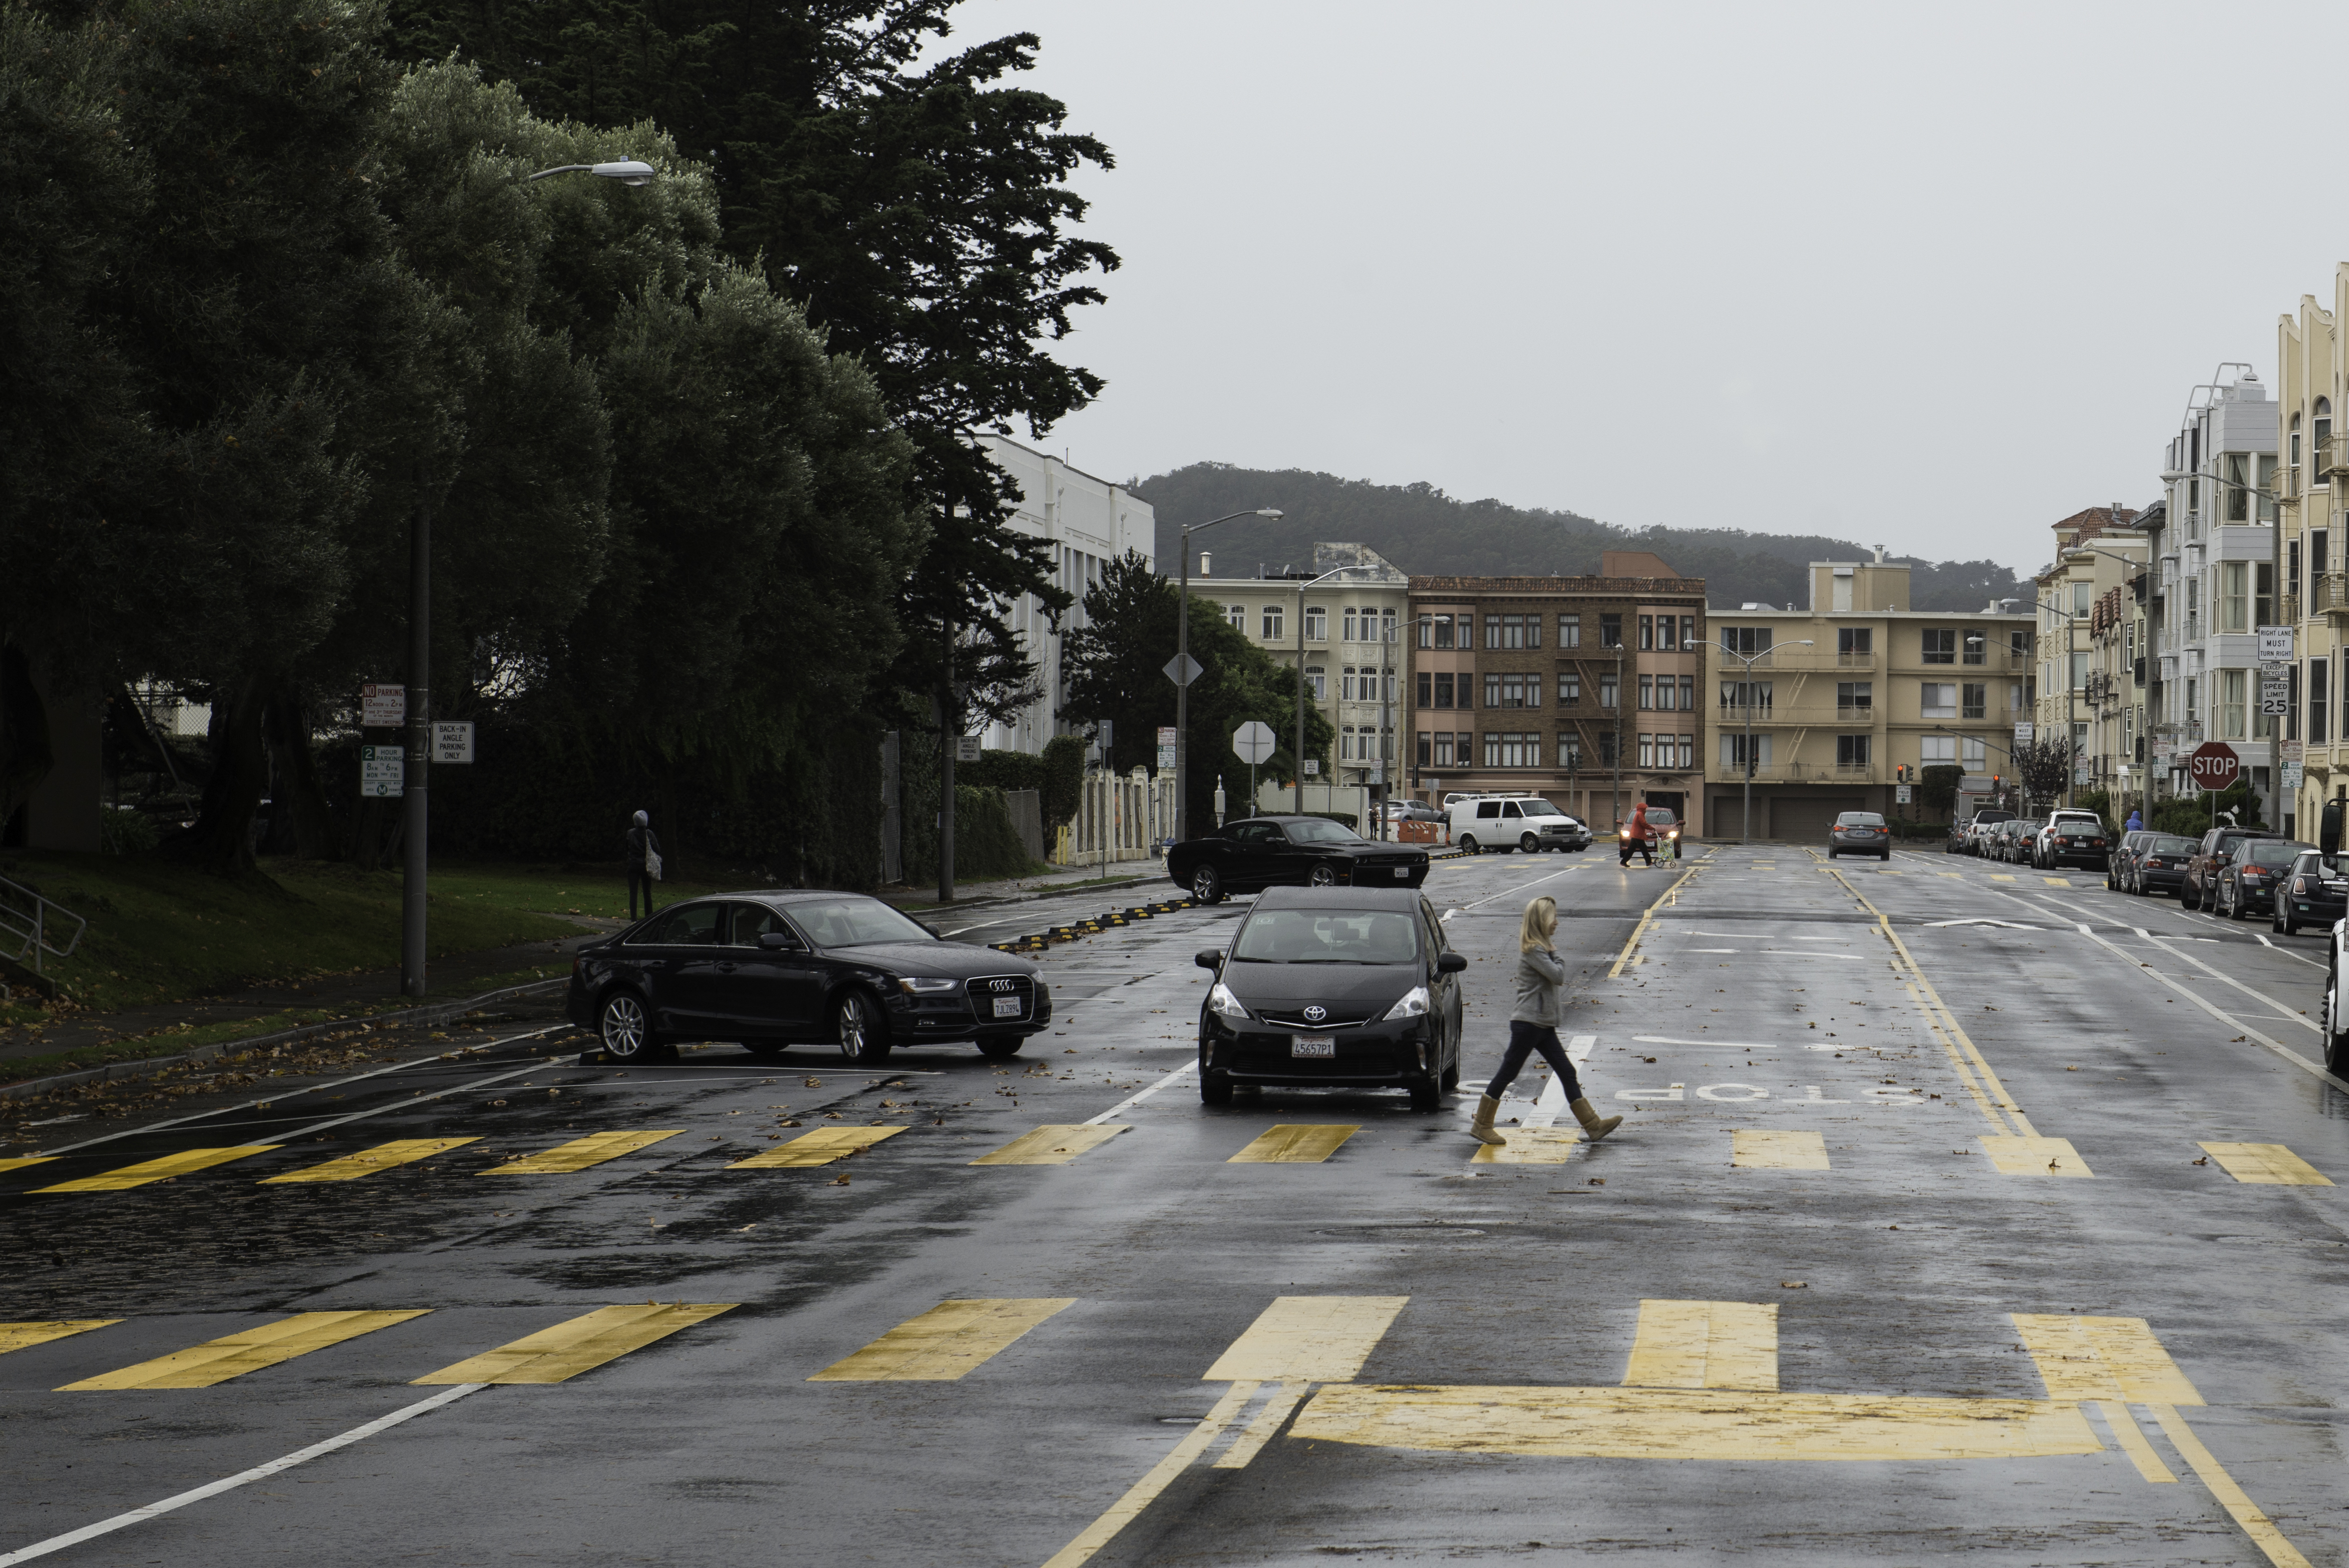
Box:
956;0;2320;569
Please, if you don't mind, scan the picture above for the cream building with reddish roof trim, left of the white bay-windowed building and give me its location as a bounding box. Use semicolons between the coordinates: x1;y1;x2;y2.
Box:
2027;503;2152;808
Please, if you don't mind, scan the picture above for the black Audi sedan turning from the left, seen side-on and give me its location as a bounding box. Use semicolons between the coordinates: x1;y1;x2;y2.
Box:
566;891;1053;1065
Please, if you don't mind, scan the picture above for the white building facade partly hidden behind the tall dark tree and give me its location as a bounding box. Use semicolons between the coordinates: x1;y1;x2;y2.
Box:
979;435;1158;757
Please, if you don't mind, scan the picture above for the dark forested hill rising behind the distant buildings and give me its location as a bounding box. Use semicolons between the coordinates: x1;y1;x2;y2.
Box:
1132;463;2030;609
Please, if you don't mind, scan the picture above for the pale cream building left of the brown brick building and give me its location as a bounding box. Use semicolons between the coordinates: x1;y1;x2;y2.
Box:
1191;543;1412;809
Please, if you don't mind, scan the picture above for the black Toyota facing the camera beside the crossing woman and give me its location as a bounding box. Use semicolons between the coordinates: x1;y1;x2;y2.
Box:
1198;888;1468;1110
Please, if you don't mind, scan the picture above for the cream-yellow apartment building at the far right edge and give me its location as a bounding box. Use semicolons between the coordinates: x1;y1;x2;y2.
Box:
2260;286;2349;837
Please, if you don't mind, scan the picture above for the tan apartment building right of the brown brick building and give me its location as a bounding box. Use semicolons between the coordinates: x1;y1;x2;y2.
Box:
1703;557;2034;842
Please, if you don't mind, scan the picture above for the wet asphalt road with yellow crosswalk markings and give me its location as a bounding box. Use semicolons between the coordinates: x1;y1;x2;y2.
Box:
0;846;2349;1565
